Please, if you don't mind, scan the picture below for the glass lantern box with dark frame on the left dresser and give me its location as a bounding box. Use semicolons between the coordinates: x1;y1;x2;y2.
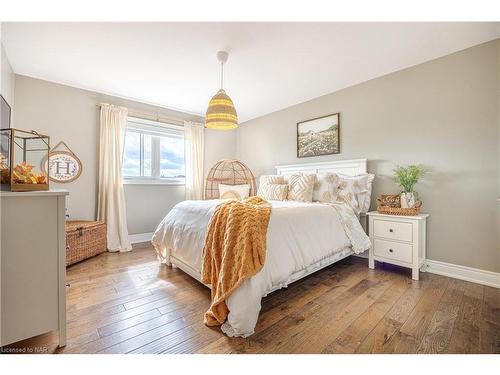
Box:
0;128;50;191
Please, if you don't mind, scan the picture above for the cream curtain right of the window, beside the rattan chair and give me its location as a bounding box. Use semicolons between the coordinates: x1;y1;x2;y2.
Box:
184;121;205;200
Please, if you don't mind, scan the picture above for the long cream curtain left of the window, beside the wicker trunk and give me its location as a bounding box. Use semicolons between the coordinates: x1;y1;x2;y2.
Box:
97;104;132;252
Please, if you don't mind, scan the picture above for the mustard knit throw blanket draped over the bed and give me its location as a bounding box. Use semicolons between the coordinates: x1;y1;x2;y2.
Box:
201;197;271;326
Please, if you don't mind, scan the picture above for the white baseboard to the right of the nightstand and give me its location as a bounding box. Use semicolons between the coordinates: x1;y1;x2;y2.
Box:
422;259;500;288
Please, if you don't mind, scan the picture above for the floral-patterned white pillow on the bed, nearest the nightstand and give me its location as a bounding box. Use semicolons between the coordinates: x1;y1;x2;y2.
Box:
338;173;375;215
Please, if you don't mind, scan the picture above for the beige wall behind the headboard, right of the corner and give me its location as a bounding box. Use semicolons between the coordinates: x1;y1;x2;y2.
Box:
237;41;500;272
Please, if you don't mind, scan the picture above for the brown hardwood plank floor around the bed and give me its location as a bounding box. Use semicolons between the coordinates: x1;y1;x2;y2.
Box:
4;244;500;353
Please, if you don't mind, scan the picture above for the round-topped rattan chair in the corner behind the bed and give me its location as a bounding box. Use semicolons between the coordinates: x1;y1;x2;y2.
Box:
205;159;256;199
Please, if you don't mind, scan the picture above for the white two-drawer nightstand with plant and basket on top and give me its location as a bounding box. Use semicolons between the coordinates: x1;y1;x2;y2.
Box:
367;211;429;280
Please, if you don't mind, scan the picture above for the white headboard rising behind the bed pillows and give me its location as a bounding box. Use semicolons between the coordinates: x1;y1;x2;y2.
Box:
276;159;366;176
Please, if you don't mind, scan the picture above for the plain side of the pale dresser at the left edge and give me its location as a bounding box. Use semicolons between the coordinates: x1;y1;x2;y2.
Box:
0;190;68;346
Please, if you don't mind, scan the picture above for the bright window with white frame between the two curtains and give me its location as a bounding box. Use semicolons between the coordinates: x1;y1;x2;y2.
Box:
122;117;185;184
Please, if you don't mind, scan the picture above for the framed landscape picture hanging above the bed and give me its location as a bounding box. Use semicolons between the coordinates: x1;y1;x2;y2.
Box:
297;113;340;158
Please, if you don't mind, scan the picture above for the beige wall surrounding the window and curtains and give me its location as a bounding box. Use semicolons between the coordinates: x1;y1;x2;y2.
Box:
15;75;236;234
